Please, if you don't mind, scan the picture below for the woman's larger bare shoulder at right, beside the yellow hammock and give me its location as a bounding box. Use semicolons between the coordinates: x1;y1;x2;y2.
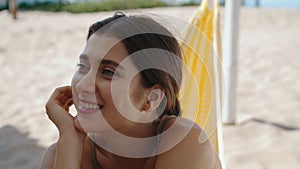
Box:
155;118;222;169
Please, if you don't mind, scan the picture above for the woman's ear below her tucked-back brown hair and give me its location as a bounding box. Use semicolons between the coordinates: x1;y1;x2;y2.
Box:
144;85;165;112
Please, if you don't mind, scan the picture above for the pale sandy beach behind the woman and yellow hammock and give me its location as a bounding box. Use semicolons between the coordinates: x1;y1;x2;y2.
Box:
0;7;300;169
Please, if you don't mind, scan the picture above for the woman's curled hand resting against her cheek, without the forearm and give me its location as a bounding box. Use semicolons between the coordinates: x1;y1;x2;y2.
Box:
46;86;85;139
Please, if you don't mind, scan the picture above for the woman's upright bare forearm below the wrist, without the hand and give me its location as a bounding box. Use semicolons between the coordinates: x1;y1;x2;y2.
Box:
54;134;83;169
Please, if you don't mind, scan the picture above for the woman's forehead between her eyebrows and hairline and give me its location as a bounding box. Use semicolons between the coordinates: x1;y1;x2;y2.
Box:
83;34;128;63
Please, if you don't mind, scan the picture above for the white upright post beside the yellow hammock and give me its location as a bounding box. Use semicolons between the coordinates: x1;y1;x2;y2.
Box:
223;0;240;124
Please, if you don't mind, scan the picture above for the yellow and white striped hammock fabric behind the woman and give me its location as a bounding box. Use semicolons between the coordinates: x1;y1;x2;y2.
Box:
181;0;223;158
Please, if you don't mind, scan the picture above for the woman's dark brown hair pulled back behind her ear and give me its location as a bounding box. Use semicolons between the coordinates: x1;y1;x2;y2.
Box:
87;12;182;116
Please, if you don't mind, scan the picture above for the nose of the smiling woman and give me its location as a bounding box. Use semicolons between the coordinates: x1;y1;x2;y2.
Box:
76;72;96;94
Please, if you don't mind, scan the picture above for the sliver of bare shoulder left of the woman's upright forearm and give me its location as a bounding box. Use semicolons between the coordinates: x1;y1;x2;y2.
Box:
40;143;56;169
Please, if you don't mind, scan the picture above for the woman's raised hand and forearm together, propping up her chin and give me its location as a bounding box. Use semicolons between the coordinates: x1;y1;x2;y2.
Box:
46;86;86;169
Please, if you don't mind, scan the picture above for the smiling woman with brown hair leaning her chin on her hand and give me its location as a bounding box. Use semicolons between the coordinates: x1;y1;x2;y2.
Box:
41;12;221;169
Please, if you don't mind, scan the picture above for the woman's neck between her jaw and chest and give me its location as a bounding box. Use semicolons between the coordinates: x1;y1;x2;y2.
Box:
92;123;156;161
